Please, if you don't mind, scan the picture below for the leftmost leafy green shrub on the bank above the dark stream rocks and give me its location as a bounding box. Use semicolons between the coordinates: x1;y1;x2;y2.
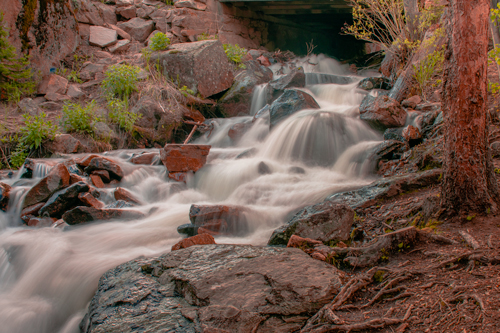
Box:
19;112;58;149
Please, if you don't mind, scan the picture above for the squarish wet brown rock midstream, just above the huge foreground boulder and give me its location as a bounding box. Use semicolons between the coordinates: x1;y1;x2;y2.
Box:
189;205;249;236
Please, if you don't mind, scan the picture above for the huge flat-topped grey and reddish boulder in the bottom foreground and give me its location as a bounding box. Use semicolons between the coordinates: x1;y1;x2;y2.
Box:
80;245;344;333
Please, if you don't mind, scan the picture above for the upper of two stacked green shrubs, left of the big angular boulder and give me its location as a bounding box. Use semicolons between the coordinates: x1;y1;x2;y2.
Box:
101;65;141;99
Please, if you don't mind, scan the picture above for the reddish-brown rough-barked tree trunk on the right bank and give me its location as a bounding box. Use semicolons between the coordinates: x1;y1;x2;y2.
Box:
442;0;498;218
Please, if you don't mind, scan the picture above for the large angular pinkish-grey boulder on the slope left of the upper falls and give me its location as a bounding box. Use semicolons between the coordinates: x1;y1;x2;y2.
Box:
151;40;234;98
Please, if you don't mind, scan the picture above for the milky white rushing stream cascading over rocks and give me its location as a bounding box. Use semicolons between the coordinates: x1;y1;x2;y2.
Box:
0;57;381;333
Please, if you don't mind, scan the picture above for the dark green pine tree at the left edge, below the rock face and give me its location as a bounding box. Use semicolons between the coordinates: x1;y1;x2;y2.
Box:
0;12;35;100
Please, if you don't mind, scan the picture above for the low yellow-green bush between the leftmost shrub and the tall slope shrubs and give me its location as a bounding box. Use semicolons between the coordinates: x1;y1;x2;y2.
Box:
61;101;99;134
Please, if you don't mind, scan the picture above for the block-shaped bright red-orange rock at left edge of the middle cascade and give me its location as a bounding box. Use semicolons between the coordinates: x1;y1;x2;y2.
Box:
160;144;211;173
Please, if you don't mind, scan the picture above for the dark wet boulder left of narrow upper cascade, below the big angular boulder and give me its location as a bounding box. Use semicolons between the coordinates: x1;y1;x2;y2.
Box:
219;60;273;117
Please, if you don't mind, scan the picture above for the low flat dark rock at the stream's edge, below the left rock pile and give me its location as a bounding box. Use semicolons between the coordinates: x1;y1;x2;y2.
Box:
62;206;145;225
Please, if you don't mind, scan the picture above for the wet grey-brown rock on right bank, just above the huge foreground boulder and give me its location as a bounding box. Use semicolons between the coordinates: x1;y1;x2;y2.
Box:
268;202;354;245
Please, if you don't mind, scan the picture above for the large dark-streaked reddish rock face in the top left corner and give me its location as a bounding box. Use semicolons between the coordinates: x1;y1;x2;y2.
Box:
0;0;80;75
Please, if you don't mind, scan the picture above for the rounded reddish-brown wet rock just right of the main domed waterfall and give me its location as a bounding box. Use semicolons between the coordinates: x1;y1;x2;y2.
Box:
359;95;407;130
